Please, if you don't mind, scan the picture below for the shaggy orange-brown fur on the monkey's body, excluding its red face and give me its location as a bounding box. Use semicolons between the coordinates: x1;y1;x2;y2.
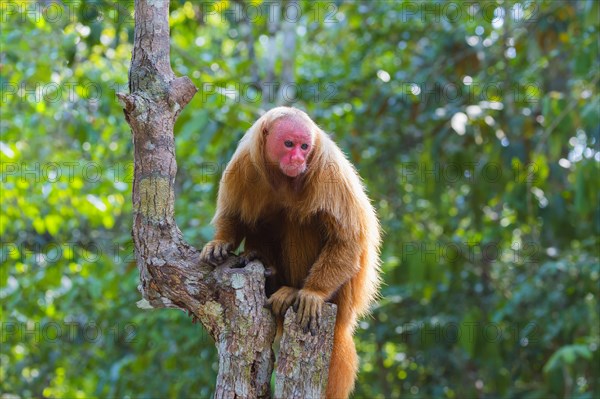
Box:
213;107;380;398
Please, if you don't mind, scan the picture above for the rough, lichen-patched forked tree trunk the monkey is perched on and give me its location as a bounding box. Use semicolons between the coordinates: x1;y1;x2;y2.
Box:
118;0;335;398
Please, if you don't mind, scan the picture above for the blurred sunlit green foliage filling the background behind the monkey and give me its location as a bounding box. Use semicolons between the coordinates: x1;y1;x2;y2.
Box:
0;0;600;398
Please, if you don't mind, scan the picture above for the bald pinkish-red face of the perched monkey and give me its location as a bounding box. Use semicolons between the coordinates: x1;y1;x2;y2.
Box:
265;118;312;177
